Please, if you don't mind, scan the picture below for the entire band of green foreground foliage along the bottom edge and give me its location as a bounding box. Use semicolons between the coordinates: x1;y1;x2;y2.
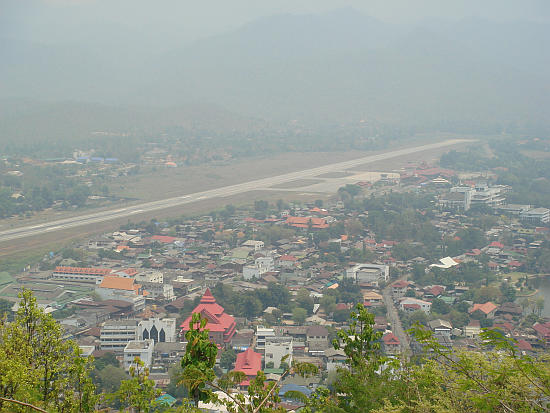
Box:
0;291;550;413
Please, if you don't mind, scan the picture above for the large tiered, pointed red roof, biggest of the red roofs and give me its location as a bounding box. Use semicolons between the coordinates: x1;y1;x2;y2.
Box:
180;288;237;346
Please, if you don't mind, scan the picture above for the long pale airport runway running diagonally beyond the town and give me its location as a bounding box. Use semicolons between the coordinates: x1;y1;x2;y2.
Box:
0;139;469;242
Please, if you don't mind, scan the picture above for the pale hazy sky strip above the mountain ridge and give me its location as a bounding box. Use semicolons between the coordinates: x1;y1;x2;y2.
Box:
4;0;550;47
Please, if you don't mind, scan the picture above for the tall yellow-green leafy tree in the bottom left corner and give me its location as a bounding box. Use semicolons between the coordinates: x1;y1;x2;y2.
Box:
0;290;97;412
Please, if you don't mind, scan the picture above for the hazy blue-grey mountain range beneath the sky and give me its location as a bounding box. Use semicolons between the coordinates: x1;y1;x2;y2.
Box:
0;9;550;140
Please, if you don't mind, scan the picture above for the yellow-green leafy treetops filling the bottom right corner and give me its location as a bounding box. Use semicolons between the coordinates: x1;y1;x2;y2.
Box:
384;327;550;413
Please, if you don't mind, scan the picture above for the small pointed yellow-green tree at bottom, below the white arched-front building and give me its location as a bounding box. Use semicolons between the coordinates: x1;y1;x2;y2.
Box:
115;357;161;413
